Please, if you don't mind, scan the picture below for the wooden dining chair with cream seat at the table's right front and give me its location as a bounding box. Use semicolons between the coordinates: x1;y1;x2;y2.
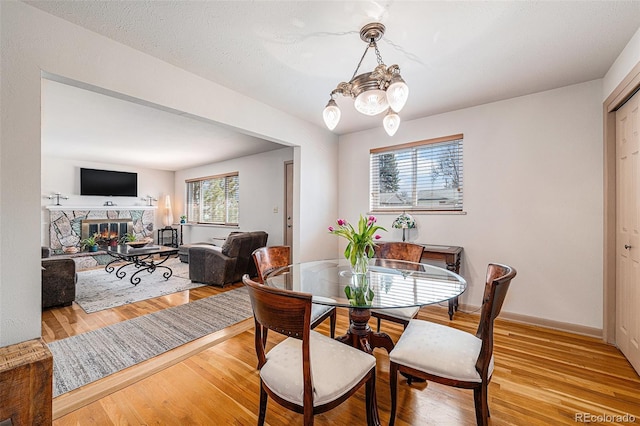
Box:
389;263;516;425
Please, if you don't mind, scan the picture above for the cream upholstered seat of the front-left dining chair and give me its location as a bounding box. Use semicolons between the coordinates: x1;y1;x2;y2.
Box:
260;331;376;406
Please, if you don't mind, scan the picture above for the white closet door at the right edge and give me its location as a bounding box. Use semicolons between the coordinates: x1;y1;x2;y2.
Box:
616;89;640;374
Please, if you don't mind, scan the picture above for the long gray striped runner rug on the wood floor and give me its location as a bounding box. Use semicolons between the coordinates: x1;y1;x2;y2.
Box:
48;287;253;397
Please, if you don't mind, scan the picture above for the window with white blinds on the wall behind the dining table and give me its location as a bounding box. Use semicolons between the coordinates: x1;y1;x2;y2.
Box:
370;135;463;212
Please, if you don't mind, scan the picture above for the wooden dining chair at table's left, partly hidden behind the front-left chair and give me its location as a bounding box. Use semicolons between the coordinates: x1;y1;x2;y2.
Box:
252;246;336;340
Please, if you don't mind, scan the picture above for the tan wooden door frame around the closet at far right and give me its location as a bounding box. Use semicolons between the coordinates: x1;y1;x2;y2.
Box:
602;62;640;344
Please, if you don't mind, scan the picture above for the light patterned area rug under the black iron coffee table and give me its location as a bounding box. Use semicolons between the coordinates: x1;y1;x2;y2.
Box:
75;258;203;314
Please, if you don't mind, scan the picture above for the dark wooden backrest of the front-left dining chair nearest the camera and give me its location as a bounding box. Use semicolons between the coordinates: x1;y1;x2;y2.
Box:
242;274;311;377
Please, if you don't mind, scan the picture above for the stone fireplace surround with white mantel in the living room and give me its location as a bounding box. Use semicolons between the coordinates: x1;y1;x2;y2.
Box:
46;206;157;253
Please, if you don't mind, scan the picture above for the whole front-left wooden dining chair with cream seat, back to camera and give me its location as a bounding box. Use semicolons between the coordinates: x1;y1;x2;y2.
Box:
242;275;379;425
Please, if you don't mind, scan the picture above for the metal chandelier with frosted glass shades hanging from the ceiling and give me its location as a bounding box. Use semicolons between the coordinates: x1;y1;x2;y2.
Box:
322;22;409;136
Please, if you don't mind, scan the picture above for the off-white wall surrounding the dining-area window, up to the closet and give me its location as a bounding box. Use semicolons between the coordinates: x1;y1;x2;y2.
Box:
338;80;603;329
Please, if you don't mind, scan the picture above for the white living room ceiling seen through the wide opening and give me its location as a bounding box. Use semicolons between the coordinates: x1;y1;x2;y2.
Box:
42;79;284;171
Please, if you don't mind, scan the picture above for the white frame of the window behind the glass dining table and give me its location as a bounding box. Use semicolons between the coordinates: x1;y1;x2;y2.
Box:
369;133;464;214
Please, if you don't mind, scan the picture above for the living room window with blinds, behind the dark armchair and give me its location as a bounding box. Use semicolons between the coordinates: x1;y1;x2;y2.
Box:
186;172;240;225
